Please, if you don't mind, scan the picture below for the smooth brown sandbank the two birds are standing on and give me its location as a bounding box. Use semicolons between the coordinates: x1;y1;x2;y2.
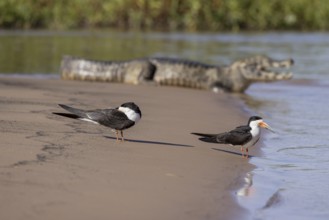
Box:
0;78;255;220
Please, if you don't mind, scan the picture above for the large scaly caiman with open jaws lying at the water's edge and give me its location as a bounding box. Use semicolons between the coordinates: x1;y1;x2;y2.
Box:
60;55;294;92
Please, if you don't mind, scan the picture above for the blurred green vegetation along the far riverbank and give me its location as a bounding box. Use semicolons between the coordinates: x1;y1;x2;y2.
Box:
0;0;329;31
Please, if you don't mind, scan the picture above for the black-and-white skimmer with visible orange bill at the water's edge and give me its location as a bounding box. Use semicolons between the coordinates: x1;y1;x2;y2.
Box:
192;116;274;158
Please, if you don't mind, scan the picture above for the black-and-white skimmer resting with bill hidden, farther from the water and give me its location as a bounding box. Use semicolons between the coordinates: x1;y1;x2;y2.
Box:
54;102;142;141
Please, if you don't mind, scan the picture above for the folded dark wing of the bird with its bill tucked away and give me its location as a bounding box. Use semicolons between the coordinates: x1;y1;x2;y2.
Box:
86;109;135;130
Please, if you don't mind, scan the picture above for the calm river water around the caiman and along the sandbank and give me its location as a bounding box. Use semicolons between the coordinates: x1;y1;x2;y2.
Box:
0;31;329;220
